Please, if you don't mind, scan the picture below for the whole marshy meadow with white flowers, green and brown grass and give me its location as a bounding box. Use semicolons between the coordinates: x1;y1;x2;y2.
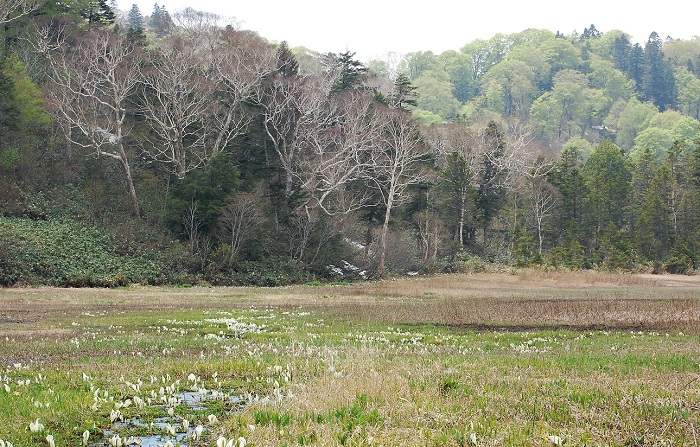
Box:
0;271;700;447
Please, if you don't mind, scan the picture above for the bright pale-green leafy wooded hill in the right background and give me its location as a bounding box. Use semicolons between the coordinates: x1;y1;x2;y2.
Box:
400;25;700;157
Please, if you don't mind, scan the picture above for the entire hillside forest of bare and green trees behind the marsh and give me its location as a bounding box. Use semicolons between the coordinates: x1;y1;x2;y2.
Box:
0;0;700;286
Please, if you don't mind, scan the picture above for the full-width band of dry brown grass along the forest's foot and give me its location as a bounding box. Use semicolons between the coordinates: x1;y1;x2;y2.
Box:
0;270;700;333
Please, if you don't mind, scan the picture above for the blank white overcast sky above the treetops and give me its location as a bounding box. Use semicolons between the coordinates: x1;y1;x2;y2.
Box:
124;0;700;62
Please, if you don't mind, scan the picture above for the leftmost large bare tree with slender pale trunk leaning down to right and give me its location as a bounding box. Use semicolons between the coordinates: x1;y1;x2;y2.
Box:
43;29;141;217
